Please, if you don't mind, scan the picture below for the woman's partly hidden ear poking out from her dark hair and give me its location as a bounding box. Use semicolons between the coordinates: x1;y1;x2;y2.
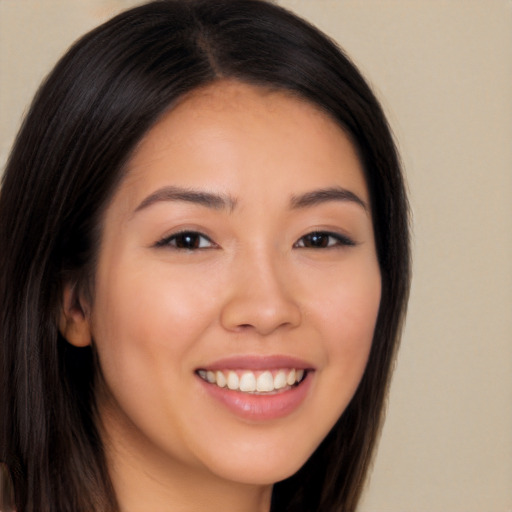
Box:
59;283;92;347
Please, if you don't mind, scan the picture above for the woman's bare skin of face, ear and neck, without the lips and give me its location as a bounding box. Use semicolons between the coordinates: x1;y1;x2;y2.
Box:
61;81;381;512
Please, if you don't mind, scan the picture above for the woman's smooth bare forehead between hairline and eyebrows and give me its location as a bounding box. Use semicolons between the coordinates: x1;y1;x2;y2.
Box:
116;81;368;212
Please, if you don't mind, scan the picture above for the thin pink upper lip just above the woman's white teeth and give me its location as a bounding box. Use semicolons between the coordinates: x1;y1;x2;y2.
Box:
197;354;314;371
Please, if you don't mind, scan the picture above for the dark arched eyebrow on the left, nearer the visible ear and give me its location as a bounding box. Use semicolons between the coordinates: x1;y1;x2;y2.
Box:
134;187;236;213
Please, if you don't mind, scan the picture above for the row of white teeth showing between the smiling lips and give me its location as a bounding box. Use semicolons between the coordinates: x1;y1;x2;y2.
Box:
196;368;308;395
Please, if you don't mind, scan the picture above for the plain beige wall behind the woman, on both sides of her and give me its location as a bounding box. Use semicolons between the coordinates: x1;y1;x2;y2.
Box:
0;0;512;512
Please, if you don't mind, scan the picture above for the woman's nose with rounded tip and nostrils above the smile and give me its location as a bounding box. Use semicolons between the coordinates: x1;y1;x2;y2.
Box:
221;251;302;336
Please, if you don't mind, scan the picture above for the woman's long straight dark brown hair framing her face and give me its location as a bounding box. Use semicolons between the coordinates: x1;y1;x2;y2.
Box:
0;0;410;512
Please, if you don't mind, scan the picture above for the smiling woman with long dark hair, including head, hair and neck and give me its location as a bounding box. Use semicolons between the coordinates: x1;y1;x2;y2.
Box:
0;0;409;512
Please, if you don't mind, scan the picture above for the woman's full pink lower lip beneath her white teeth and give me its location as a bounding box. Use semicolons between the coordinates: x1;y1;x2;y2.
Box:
198;371;313;421
